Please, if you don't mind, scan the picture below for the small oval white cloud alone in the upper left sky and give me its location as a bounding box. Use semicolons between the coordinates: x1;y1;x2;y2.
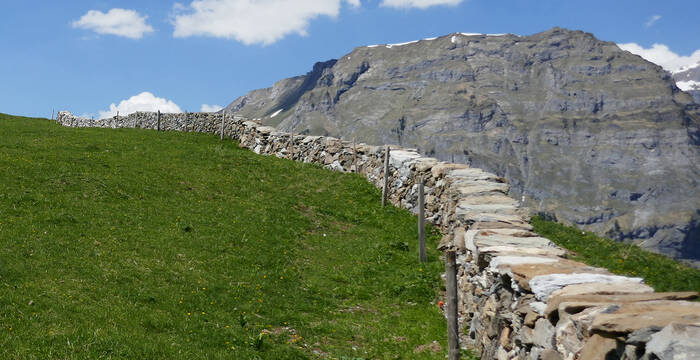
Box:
73;9;153;39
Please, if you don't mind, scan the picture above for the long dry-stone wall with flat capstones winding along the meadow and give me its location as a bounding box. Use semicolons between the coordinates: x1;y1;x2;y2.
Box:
57;112;700;359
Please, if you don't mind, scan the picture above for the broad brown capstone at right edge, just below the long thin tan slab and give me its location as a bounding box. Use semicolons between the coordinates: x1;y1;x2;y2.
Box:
591;301;700;333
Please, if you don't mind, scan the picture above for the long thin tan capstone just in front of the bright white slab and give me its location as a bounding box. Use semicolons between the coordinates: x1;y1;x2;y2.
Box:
545;291;698;317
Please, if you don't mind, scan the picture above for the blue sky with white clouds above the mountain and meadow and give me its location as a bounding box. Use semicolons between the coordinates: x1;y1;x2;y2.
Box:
0;0;700;117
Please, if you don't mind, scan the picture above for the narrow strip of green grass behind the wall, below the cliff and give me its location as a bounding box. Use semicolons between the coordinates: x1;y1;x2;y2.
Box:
532;217;700;291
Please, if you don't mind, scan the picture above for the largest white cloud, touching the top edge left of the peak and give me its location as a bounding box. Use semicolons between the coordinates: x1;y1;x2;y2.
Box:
173;0;361;45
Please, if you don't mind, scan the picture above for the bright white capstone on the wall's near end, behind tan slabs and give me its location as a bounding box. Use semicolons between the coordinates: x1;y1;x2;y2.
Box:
527;267;644;301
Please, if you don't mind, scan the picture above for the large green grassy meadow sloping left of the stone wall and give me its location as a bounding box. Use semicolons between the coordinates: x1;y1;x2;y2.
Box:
0;114;464;359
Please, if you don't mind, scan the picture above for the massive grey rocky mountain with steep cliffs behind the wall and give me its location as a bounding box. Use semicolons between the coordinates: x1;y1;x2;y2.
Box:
227;28;700;260
